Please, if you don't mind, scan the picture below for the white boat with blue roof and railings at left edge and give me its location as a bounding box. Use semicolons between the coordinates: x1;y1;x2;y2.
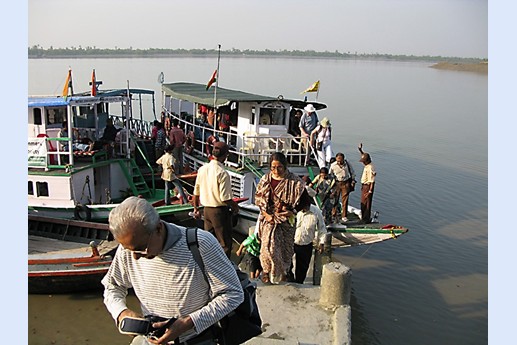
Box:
28;89;154;211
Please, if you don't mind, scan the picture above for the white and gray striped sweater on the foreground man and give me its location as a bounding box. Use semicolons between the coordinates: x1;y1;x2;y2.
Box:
102;223;244;341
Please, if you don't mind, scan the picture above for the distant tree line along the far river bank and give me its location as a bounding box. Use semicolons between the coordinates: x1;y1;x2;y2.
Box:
28;45;486;63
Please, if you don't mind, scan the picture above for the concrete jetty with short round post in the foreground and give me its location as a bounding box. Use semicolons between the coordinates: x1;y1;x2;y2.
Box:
245;262;352;345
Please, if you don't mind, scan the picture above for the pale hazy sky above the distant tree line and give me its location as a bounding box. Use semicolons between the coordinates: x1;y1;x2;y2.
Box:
28;0;488;58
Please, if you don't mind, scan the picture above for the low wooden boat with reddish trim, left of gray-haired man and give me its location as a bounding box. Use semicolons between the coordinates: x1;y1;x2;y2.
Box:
28;215;118;294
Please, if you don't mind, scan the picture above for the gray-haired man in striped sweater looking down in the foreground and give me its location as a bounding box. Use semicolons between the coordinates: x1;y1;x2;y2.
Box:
102;196;244;345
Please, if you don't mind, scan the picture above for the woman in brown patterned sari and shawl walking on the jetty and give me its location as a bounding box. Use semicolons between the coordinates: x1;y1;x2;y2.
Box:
255;152;307;284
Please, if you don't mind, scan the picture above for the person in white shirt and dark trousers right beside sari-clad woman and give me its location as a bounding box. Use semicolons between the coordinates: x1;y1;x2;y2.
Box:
288;194;327;284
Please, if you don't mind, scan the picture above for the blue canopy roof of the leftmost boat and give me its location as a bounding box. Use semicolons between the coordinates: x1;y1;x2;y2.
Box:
28;89;154;108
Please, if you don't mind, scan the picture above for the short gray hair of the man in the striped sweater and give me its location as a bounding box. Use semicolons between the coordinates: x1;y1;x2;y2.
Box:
109;196;160;238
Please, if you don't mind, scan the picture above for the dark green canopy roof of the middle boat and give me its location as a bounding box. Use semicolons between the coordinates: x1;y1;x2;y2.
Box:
162;82;327;110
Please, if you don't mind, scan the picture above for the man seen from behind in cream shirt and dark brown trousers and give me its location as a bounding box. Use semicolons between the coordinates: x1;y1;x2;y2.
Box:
194;141;239;258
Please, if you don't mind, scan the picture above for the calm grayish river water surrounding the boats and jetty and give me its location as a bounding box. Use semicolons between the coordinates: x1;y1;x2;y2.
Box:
28;58;488;345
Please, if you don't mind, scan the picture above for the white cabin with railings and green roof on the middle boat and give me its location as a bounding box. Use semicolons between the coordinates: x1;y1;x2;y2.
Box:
162;82;326;167
